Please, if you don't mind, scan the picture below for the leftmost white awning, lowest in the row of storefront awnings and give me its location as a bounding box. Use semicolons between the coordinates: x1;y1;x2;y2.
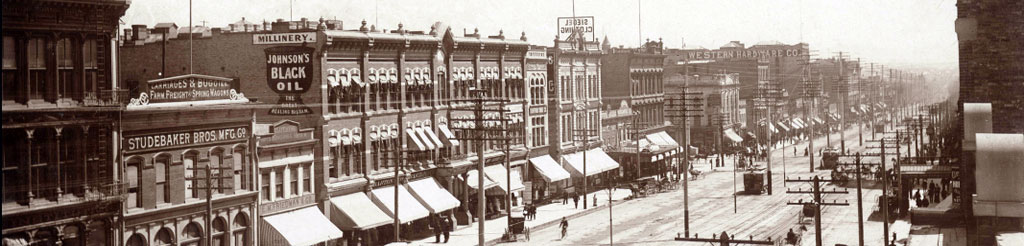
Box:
260;206;342;246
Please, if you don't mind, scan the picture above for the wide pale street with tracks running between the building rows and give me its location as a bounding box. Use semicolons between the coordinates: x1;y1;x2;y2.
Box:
513;125;905;245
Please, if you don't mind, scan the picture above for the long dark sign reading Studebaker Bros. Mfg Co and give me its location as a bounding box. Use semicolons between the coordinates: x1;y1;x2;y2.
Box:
124;126;249;152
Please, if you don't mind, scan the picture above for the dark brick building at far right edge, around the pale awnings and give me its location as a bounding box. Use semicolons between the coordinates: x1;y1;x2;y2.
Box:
955;0;1024;245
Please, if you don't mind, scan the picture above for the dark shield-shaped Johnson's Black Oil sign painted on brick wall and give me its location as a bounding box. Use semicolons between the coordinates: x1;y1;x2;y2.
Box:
264;46;313;115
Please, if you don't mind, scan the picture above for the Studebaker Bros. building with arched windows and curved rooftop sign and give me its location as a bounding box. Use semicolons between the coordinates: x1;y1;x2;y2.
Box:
119;75;258;246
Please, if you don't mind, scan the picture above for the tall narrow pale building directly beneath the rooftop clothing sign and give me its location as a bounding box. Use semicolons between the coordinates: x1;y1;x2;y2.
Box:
548;33;618;193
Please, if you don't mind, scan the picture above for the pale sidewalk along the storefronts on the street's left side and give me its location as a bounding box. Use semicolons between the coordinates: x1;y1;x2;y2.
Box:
411;189;632;245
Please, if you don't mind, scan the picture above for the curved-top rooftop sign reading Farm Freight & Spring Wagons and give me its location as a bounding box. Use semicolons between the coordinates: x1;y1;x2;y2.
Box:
145;75;234;104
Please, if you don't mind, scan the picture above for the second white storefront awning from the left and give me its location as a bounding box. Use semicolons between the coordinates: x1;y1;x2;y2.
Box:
331;193;393;231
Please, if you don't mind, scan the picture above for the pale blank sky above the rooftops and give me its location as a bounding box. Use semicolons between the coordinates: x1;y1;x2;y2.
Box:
122;0;958;69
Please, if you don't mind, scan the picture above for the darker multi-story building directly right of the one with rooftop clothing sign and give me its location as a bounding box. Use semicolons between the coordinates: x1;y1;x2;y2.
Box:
601;38;681;178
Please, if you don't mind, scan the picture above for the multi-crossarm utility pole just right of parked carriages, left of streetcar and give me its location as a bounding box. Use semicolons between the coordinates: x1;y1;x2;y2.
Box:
663;88;704;237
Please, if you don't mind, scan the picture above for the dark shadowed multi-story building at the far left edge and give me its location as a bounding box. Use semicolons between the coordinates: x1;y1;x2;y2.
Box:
2;0;130;245
